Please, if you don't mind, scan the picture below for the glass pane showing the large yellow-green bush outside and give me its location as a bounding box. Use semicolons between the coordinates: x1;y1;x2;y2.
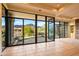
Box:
24;19;35;44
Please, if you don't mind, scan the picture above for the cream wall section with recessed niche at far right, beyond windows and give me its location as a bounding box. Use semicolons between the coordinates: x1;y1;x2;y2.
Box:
68;20;76;39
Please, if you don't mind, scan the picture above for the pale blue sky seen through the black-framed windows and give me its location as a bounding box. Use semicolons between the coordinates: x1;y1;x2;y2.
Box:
2;18;45;26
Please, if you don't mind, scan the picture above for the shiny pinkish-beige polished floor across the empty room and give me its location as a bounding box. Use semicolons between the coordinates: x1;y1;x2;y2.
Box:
2;38;79;56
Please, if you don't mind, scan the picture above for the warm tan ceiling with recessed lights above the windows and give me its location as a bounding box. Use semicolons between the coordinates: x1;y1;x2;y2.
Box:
6;3;79;21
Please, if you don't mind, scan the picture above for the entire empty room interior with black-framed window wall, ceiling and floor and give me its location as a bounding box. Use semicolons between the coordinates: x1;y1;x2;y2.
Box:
0;3;79;56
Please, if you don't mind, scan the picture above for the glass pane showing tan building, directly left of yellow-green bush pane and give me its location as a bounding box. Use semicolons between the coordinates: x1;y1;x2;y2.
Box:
11;19;23;45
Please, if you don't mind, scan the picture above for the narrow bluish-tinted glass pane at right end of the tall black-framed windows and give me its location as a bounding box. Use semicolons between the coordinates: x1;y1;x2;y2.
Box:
47;18;54;41
